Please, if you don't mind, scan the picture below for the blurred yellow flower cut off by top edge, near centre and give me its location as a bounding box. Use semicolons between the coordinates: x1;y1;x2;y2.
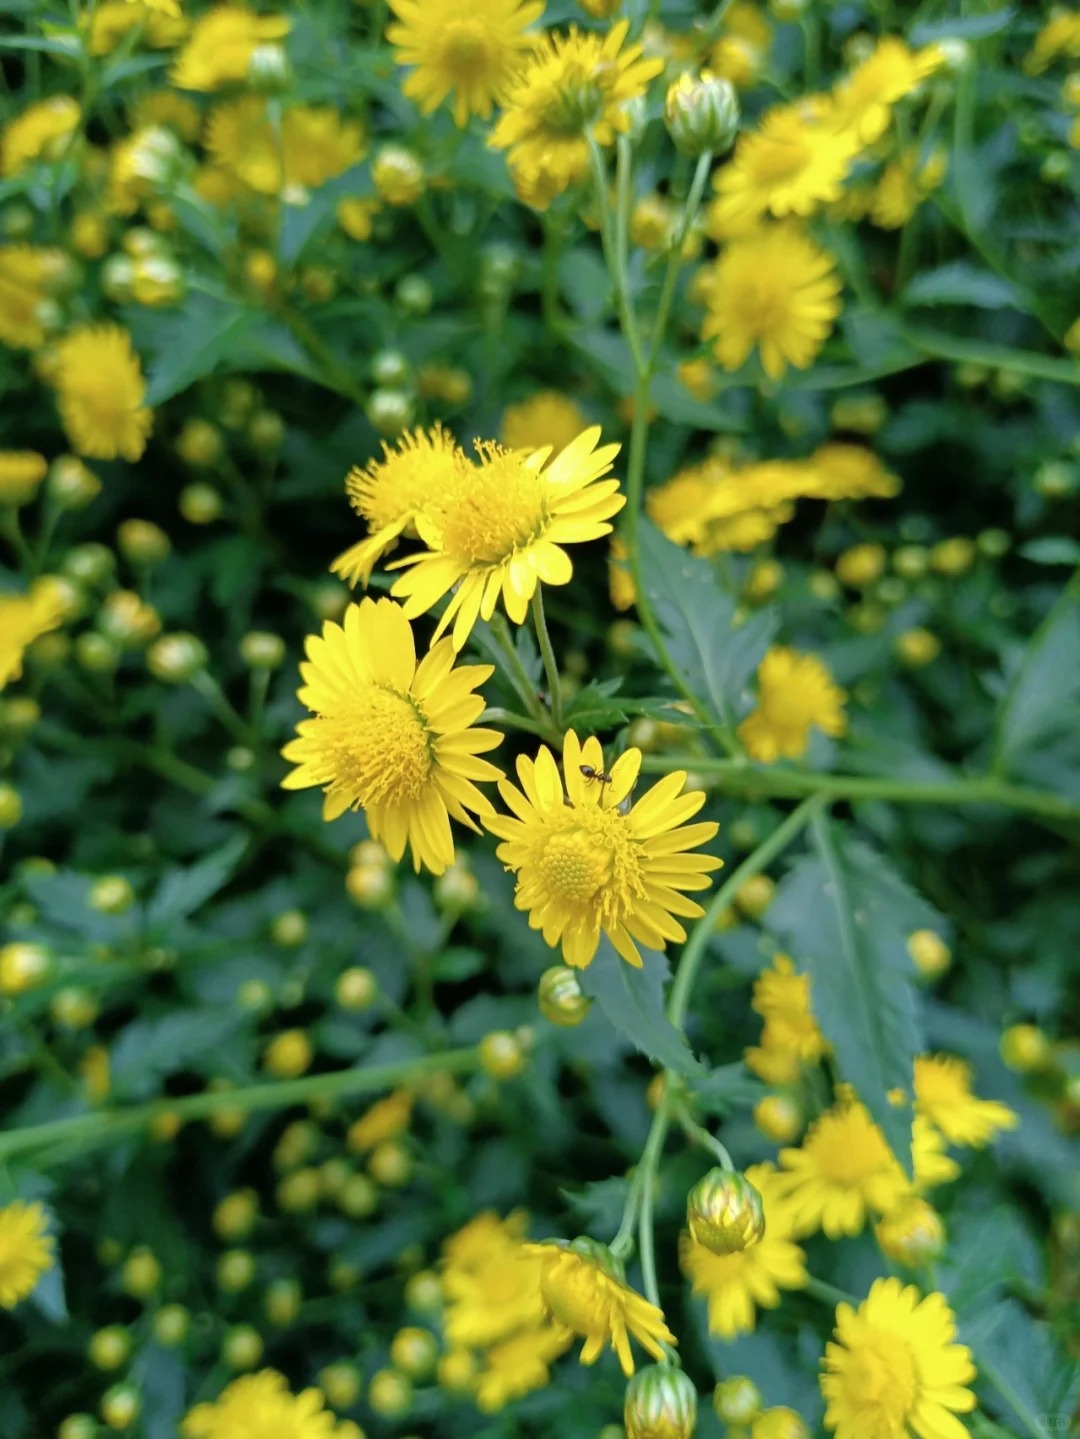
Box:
387;0;544;125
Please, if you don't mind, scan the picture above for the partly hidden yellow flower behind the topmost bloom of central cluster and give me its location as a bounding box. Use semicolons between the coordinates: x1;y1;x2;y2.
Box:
331;425;472;584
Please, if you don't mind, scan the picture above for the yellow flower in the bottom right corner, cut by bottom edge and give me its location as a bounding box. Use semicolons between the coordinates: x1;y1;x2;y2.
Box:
821;1279;975;1439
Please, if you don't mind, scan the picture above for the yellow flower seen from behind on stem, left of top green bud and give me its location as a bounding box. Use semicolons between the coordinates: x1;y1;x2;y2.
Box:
489;20;663;200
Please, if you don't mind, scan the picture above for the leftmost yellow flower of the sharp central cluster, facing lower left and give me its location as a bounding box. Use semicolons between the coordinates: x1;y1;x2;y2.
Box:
282;600;502;875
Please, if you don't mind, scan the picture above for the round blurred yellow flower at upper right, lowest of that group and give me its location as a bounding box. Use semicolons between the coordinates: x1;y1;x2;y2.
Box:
702;224;843;380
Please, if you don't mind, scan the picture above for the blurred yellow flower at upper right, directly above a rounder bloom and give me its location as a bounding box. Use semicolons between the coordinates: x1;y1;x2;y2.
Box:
708;96;859;239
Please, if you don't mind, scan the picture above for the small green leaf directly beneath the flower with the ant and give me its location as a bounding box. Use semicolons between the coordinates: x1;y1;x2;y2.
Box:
580;937;705;1079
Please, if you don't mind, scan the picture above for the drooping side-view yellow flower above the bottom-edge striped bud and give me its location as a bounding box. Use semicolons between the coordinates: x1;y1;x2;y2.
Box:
525;1239;677;1377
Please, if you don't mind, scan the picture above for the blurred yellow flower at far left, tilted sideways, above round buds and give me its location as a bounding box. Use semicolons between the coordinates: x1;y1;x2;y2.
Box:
55;325;154;460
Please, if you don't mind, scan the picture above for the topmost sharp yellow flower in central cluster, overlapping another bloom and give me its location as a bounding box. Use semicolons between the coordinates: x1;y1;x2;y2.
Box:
390;426;626;649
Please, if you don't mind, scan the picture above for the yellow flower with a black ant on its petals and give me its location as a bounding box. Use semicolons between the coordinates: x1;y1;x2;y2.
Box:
483;730;722;968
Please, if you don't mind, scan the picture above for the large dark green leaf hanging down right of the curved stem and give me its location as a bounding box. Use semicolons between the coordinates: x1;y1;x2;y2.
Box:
765;817;941;1173
